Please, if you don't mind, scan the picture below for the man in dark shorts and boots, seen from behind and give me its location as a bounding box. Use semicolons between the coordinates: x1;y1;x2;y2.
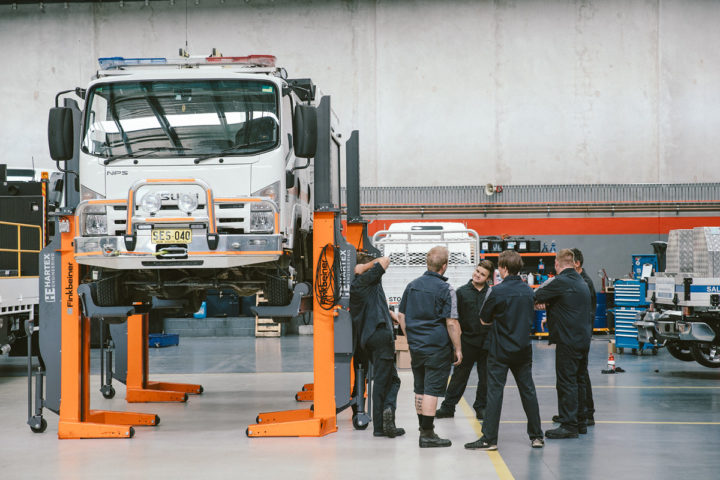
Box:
398;246;462;448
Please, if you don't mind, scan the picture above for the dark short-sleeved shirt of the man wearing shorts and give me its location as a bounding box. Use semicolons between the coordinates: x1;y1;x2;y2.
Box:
400;270;458;355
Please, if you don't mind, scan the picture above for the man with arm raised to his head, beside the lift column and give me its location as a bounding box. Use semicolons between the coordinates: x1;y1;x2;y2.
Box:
350;254;405;438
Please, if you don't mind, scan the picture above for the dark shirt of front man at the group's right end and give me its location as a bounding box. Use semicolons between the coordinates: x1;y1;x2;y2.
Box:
535;268;592;351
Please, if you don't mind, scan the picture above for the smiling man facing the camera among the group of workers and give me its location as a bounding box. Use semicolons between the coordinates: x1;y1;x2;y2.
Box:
435;260;495;420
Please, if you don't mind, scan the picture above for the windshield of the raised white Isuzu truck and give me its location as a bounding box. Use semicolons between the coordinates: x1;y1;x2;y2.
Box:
82;80;279;163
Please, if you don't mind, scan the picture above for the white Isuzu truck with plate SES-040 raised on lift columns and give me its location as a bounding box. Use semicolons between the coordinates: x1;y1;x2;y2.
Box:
48;55;317;311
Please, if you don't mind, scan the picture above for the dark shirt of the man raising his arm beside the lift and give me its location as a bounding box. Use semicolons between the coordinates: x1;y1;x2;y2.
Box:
350;263;393;348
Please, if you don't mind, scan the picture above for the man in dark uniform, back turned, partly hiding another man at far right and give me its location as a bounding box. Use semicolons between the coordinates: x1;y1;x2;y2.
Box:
535;248;592;438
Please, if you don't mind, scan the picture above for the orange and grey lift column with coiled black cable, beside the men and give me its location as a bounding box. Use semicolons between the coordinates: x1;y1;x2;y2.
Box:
246;97;355;437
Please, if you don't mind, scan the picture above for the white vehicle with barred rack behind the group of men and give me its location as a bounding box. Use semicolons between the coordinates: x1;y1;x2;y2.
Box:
372;222;480;308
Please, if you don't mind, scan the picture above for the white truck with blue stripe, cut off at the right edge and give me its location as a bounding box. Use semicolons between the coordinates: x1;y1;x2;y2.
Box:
634;227;720;368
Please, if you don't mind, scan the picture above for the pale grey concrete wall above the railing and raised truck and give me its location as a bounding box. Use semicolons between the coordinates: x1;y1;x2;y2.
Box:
0;0;720;186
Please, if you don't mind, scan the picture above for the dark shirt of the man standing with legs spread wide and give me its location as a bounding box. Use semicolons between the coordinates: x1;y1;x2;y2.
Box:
480;275;535;364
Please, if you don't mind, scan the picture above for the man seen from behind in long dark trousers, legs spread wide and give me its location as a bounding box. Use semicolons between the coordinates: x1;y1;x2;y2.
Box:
465;250;544;450
